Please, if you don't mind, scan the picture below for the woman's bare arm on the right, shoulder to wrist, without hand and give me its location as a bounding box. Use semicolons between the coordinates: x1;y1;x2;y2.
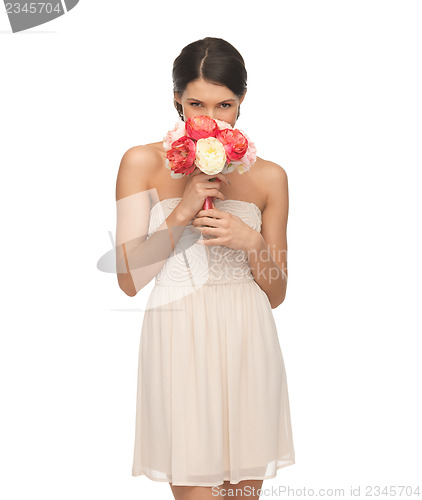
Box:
247;162;289;309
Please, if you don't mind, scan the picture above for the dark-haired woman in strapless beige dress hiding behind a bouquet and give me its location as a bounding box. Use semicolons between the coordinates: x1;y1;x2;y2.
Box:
116;37;295;499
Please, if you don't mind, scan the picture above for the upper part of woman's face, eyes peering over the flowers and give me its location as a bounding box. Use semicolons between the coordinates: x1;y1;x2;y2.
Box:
174;79;246;127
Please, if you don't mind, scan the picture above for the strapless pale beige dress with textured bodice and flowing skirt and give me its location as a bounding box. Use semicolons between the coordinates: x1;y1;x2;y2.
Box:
132;198;295;486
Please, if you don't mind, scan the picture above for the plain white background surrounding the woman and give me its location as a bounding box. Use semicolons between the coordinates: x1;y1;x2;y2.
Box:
0;0;422;500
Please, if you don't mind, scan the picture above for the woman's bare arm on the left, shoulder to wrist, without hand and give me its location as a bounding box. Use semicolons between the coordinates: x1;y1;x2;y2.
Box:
116;146;190;297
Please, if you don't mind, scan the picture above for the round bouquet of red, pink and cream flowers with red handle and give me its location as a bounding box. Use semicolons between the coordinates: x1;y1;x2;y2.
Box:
163;115;256;210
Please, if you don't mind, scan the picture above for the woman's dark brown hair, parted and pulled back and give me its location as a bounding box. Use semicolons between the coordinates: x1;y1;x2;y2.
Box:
173;36;247;120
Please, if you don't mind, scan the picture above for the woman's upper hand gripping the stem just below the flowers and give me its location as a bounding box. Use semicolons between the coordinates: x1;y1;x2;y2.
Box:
175;167;230;219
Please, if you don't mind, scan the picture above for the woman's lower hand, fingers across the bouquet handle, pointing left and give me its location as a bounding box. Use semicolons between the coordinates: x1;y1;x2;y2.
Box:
192;207;260;250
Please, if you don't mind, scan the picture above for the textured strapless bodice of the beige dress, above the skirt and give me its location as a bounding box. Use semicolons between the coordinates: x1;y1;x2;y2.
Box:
148;198;262;287
